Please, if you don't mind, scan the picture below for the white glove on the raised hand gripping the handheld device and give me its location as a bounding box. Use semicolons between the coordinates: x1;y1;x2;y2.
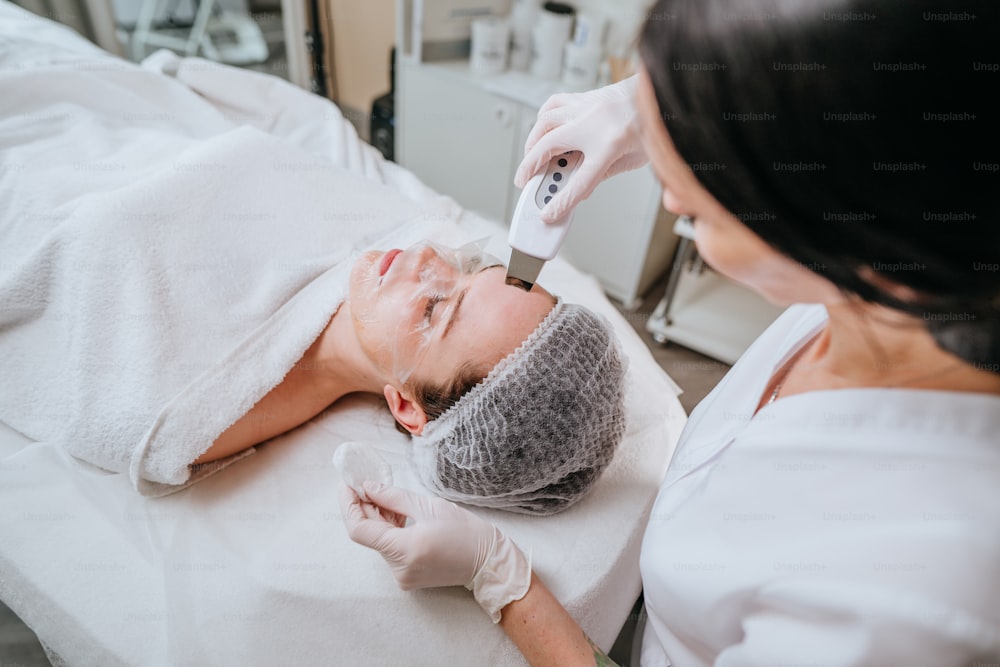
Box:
514;75;649;222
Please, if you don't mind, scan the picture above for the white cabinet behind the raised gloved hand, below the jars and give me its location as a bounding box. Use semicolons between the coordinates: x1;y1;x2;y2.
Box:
395;56;676;307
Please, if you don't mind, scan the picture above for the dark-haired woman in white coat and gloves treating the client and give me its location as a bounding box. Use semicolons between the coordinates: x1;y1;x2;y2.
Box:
344;0;1000;667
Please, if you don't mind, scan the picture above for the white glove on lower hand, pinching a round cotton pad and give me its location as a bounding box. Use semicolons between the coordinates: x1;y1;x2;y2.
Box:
341;482;531;623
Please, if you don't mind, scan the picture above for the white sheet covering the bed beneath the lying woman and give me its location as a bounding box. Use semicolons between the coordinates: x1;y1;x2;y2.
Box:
0;2;686;665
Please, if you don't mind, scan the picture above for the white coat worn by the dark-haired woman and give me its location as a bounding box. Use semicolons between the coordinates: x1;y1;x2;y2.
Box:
641;306;1000;667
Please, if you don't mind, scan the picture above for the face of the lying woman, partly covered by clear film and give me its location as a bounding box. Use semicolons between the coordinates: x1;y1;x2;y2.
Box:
349;244;554;384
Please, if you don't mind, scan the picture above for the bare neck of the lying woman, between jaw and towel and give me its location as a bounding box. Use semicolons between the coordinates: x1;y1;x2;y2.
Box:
294;302;385;403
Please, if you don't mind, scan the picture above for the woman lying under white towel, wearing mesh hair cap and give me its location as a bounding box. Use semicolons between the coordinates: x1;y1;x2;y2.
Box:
0;45;625;514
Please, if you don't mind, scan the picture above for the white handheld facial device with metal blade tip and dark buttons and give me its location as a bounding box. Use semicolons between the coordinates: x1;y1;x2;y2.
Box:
507;151;583;292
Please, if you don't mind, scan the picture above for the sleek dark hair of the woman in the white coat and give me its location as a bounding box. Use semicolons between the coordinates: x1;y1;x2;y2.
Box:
639;0;1000;372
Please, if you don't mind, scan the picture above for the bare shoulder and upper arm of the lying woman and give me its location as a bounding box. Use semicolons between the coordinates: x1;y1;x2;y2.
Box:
195;337;335;464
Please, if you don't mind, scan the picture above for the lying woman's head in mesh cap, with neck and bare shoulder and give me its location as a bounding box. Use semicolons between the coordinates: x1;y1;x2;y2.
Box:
195;242;625;514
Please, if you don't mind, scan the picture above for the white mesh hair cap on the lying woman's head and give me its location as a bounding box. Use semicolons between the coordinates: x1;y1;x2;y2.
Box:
412;300;626;514
